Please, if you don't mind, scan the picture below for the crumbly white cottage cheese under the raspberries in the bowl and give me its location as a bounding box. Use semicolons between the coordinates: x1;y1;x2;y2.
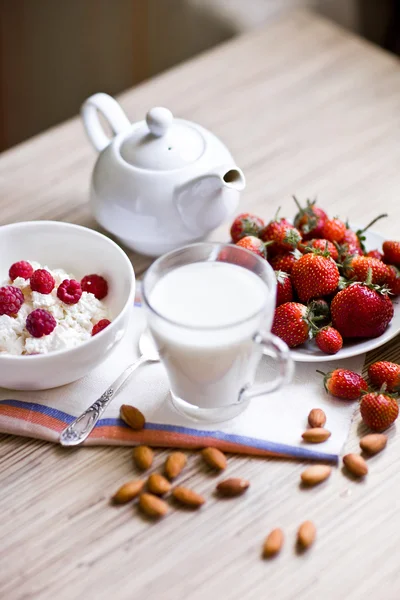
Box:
0;261;109;355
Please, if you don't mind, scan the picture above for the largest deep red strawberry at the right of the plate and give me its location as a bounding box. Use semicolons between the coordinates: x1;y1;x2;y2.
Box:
331;282;393;338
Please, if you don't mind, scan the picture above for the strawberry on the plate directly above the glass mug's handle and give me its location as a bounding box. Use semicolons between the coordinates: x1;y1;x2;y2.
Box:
271;302;310;348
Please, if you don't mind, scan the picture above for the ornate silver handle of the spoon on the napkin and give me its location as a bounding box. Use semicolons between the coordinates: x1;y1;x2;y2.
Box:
60;354;147;446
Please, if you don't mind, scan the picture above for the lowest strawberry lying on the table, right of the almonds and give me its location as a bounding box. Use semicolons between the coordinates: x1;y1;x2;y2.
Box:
360;392;399;431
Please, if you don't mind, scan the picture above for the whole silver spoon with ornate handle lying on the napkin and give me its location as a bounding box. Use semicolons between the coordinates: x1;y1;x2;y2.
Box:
60;329;160;446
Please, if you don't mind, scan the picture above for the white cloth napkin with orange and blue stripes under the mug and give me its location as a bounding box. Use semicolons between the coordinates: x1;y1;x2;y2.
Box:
0;302;364;462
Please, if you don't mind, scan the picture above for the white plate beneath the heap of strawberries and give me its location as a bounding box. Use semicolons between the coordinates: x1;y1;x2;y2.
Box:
290;226;400;362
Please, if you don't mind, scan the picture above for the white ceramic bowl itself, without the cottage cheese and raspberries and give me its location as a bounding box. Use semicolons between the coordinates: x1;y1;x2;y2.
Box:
0;221;135;390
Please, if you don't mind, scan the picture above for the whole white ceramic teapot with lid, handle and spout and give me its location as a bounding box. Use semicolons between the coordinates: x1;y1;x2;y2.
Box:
81;94;245;256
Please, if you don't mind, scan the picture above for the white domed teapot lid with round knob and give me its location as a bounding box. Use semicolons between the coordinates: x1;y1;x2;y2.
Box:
120;107;205;171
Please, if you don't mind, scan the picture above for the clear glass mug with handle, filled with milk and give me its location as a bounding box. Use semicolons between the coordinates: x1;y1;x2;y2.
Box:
142;242;294;422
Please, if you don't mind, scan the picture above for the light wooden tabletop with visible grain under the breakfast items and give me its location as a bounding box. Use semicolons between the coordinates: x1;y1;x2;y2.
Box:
0;13;400;600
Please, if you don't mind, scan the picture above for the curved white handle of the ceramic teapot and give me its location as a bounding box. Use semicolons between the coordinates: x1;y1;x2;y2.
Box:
81;93;130;152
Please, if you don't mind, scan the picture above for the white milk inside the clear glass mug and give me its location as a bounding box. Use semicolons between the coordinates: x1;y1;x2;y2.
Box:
149;262;275;408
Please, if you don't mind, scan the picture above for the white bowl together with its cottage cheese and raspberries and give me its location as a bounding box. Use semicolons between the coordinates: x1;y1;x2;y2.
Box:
0;221;135;390
